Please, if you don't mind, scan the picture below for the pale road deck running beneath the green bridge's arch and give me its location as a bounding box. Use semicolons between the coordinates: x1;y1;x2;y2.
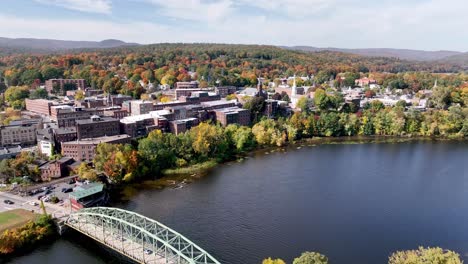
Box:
67;223;176;264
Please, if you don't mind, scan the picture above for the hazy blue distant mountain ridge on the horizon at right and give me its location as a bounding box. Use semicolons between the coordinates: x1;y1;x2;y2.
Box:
283;46;468;61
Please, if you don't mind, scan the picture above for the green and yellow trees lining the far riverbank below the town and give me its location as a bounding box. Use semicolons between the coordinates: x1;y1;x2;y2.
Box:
78;104;468;182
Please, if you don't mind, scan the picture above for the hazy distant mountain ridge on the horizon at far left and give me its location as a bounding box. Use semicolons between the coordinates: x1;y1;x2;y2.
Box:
0;37;139;52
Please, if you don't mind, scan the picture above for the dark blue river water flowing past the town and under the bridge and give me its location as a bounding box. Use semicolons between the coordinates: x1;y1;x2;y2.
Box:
3;141;468;264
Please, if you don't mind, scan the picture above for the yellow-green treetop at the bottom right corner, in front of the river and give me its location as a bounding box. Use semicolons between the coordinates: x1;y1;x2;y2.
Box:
388;247;463;264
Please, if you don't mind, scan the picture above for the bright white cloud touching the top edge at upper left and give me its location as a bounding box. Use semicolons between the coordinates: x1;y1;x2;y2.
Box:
34;0;112;14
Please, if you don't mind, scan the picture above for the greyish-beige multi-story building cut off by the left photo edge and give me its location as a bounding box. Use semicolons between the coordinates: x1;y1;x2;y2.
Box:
0;119;42;146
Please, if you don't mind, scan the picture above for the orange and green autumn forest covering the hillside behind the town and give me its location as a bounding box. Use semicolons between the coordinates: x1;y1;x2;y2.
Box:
0;44;460;98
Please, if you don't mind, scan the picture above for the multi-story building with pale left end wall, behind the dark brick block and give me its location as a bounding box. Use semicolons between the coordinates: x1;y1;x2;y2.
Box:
51;106;104;128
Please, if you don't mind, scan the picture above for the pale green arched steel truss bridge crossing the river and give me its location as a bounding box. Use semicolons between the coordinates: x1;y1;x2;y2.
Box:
65;207;220;264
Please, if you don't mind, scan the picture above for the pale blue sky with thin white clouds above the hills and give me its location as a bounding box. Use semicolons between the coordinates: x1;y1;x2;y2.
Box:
0;0;468;51
